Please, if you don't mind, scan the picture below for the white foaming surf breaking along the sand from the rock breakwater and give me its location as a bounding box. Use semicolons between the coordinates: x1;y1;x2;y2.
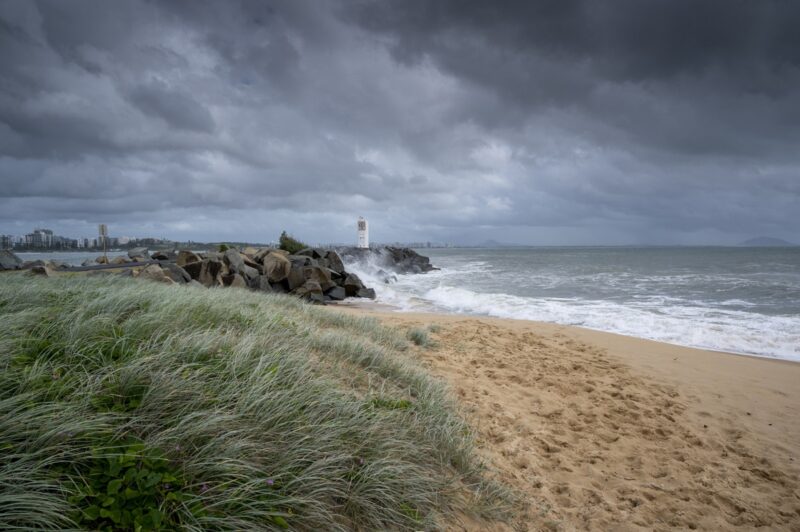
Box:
340;252;800;361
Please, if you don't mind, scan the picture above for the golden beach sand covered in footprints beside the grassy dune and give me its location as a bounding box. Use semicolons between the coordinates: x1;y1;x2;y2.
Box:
328;306;800;530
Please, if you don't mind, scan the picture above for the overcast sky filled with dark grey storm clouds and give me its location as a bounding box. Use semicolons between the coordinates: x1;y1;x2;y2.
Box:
0;0;800;244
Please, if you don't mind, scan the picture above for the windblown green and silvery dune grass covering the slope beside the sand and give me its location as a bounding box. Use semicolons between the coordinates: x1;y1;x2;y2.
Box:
0;273;508;530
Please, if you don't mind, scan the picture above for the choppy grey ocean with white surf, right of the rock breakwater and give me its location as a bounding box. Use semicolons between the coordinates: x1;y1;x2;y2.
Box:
348;247;800;361
